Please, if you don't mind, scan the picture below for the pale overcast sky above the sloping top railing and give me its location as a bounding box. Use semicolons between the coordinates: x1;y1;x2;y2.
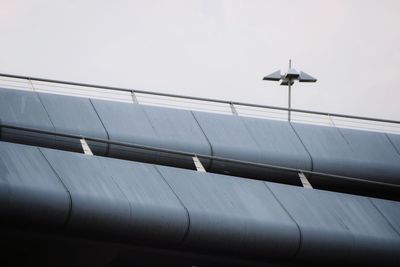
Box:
0;0;400;120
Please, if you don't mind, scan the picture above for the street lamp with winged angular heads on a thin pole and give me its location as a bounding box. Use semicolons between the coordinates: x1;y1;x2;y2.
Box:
263;59;317;121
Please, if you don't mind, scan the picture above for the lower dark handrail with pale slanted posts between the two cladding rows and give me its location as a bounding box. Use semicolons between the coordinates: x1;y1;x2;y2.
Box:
0;123;400;201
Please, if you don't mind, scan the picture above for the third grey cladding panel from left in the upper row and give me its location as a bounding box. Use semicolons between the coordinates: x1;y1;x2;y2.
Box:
91;99;161;162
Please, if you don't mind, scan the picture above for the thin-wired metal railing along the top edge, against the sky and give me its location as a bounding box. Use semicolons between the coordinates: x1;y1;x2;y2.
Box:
0;73;400;134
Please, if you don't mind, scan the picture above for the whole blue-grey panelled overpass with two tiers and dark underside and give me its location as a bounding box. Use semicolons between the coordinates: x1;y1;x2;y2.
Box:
0;75;400;266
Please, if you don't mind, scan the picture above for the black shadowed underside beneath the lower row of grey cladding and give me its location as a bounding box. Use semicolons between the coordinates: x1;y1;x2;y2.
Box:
0;226;300;267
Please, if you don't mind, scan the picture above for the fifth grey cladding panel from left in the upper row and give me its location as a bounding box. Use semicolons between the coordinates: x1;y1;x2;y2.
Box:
193;111;262;175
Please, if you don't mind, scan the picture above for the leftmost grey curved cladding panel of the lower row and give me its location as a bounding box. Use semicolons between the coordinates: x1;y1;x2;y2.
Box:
0;142;70;228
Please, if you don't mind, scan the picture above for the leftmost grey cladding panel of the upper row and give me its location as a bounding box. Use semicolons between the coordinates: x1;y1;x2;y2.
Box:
0;88;55;147
